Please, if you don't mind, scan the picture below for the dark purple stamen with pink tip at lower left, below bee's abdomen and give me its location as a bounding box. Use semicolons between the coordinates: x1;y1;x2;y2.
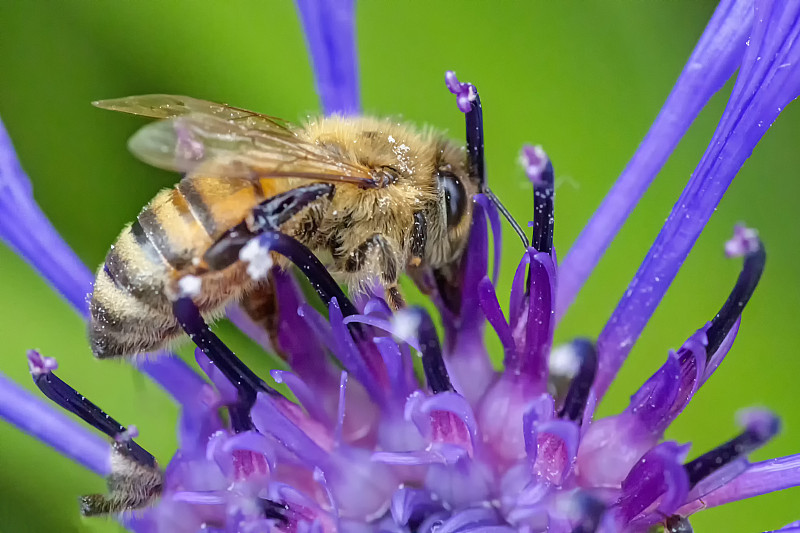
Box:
28;350;156;468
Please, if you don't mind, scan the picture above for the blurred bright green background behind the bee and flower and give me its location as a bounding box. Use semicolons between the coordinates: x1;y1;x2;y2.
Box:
0;0;800;532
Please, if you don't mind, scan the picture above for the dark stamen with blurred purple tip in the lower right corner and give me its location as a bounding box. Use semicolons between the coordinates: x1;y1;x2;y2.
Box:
684;410;780;487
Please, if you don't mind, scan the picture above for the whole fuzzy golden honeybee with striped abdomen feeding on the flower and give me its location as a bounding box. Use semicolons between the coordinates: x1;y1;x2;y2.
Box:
89;95;480;358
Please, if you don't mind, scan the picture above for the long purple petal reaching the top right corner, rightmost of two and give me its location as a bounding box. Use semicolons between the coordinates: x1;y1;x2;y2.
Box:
595;0;800;397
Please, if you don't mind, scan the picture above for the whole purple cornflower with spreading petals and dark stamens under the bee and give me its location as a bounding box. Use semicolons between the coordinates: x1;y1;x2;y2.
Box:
0;0;800;533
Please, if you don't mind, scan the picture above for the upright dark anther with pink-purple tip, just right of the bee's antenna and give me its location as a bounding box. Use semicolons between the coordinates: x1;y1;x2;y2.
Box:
521;146;555;254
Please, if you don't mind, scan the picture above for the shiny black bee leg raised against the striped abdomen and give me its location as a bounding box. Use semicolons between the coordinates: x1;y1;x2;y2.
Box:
203;183;334;270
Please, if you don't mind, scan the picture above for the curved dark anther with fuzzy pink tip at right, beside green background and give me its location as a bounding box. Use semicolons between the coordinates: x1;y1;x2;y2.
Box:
706;226;767;358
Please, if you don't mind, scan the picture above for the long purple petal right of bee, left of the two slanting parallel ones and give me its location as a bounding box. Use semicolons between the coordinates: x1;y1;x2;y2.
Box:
556;0;753;320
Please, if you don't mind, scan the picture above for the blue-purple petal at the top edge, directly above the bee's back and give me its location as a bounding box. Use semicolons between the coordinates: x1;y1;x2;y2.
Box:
296;0;361;115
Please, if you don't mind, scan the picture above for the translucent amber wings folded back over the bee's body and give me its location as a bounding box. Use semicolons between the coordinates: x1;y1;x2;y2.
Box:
94;95;377;187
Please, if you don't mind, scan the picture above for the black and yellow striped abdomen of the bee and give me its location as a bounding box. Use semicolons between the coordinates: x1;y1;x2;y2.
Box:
89;176;288;358
